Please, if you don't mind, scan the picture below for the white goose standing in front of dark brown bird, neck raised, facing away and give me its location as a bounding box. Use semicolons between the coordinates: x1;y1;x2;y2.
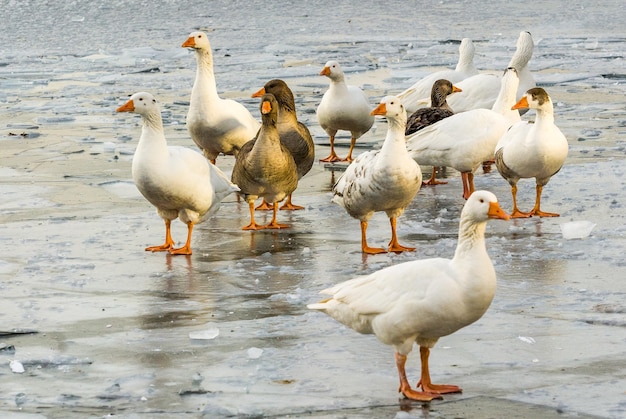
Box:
406;68;520;199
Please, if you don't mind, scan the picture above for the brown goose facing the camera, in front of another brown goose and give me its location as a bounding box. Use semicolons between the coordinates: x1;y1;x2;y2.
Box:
232;94;298;230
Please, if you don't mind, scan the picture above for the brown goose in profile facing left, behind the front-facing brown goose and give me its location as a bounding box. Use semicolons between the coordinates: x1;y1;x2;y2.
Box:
252;79;315;210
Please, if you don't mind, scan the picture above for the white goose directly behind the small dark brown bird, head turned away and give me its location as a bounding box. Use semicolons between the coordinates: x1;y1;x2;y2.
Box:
398;38;478;112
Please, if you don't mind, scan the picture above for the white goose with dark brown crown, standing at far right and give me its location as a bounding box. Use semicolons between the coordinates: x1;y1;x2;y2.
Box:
495;87;568;218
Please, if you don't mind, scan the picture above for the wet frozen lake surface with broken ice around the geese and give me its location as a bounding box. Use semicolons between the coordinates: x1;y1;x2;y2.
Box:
0;0;626;418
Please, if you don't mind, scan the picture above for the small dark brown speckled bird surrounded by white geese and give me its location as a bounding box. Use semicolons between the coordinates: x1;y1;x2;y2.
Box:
405;79;461;185
